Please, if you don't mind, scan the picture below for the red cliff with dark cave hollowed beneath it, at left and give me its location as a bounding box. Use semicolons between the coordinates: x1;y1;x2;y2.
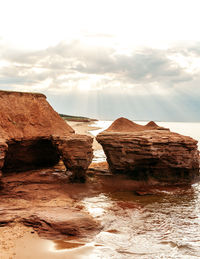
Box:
0;91;93;182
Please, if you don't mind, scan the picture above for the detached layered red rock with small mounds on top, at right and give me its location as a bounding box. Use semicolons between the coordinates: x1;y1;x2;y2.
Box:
97;118;199;184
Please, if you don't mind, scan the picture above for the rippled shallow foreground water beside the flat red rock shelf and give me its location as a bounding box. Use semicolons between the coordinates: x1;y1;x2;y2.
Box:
14;184;200;259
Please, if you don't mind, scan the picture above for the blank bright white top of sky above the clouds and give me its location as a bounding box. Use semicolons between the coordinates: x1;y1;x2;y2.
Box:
0;0;200;48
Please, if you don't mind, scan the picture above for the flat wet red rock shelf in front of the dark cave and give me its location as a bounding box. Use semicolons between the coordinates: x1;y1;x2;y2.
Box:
0;166;101;241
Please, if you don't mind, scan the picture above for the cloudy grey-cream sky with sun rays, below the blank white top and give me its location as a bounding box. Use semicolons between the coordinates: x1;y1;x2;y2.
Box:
0;41;200;121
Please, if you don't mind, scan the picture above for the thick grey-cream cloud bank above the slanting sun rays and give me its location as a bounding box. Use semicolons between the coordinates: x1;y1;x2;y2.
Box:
0;40;200;95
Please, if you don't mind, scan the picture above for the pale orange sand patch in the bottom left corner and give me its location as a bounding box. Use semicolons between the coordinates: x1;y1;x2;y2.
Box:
0;230;93;259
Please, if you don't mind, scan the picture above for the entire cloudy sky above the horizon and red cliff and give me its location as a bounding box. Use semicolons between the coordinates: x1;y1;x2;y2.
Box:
0;0;200;122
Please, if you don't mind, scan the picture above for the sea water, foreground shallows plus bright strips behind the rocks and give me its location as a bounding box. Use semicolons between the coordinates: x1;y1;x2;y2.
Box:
83;121;200;259
